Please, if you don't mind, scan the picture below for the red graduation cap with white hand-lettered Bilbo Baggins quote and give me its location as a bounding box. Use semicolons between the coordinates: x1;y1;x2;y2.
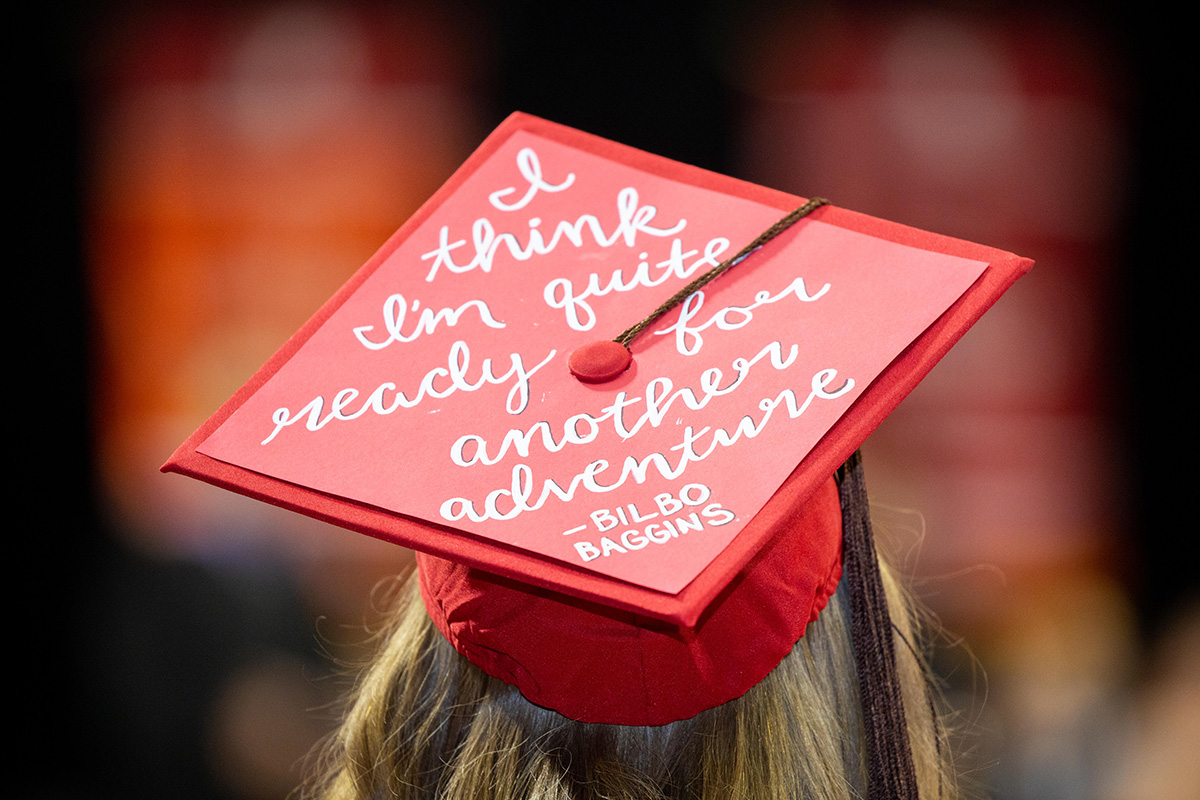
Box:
163;114;1032;786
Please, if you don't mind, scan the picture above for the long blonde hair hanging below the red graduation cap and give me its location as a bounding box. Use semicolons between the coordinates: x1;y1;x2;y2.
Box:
306;556;959;800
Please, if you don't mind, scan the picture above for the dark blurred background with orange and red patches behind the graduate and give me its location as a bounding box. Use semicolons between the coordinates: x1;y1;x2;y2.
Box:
28;0;1200;800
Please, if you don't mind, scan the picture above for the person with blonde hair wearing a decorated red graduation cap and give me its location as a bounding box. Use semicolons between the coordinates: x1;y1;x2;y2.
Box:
154;114;1032;800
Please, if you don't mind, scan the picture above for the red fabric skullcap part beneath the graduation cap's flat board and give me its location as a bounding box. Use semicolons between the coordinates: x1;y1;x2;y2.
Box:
416;477;841;726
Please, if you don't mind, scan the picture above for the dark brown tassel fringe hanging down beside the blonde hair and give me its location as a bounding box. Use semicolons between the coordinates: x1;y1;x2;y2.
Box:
838;451;918;800
